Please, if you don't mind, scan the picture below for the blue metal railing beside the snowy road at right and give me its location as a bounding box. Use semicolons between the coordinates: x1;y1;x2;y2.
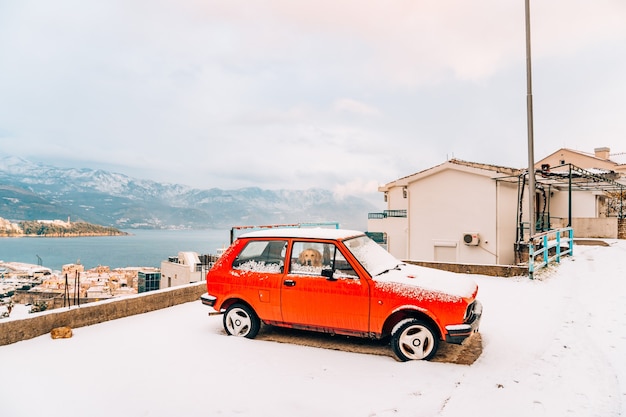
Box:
528;227;574;279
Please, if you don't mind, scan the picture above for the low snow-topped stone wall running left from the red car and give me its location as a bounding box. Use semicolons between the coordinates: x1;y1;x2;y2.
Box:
0;282;206;346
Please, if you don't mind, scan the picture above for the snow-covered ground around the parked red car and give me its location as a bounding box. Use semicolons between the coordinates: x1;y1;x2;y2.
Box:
0;240;626;417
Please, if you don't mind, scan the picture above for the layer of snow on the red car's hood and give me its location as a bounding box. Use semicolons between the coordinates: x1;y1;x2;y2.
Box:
373;263;478;298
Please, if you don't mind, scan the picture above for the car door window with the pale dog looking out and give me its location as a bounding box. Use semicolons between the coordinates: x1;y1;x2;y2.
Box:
289;241;358;278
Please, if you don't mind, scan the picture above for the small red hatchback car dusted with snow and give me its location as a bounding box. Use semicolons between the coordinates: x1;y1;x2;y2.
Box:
201;228;482;361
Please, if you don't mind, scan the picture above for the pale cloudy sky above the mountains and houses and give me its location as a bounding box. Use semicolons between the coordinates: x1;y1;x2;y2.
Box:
0;0;626;202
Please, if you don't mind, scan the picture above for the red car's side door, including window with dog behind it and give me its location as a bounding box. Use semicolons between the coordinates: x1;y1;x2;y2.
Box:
281;241;369;333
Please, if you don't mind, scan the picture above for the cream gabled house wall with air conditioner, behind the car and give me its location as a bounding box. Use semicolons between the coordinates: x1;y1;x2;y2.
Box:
368;163;518;264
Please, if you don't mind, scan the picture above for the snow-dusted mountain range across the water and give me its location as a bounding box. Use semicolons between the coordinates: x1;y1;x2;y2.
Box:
0;156;377;230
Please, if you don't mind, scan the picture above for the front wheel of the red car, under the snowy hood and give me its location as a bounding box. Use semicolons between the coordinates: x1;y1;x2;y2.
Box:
391;318;439;362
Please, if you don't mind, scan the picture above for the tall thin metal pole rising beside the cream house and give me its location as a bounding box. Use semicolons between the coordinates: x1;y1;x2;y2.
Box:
525;0;535;241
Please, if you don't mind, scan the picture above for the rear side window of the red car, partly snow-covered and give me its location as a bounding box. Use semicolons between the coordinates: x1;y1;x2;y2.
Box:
233;240;287;273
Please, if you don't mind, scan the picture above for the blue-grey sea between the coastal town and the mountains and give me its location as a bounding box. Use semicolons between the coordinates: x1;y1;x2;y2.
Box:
0;229;230;271
